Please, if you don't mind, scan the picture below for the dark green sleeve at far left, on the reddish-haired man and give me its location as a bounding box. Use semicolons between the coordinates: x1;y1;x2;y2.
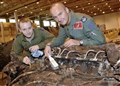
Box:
11;38;25;61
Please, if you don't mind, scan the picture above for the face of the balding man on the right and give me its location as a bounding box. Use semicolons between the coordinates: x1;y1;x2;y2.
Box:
50;6;69;25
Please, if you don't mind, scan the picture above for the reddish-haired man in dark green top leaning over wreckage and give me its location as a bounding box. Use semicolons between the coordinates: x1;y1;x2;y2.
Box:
11;18;54;64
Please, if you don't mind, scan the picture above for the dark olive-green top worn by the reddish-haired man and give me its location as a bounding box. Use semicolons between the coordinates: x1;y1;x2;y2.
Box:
11;29;54;60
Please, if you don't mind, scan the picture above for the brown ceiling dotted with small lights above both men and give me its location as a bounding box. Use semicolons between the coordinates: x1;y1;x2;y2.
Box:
0;0;120;18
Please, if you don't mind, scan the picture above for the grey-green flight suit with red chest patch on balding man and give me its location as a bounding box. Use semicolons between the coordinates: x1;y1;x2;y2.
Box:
51;11;105;47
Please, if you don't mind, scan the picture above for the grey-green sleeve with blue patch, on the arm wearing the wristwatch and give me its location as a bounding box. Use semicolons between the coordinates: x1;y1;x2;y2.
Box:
82;19;105;45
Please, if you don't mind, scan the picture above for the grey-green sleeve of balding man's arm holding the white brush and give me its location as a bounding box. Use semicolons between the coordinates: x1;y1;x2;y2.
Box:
51;27;67;47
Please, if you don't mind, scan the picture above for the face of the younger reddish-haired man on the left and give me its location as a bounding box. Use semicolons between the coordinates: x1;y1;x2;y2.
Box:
20;22;33;38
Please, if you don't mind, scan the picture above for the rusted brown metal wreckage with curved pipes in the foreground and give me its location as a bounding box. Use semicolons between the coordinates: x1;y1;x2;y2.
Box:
3;43;120;86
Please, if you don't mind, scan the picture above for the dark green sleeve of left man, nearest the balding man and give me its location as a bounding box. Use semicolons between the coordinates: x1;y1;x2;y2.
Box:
38;30;54;49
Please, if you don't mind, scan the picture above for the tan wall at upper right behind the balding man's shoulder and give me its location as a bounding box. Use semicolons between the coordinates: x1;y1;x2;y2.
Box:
94;12;120;29
